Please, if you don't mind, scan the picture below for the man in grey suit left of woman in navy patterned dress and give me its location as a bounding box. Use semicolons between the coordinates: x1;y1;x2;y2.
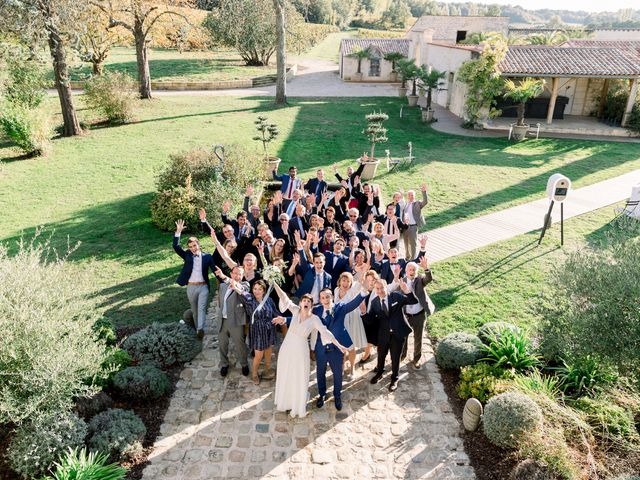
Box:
216;265;249;377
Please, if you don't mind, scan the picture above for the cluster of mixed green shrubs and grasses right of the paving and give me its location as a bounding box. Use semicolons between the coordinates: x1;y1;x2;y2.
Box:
436;322;640;479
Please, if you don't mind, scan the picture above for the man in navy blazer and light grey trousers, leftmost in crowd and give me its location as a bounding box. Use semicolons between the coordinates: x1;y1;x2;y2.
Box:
173;220;215;339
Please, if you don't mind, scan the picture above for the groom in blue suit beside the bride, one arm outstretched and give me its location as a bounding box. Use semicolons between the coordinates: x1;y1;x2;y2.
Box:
311;288;369;410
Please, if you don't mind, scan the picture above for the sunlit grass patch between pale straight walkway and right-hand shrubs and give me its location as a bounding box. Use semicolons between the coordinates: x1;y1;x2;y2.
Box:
428;203;624;338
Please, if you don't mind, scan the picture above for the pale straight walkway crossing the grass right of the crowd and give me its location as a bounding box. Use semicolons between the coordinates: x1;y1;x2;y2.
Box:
424;170;640;262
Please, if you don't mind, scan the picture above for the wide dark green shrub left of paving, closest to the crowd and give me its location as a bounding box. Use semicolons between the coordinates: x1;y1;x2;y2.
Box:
122;323;202;367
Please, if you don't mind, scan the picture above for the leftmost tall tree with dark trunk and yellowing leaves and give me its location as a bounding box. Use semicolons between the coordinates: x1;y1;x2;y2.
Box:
0;0;87;137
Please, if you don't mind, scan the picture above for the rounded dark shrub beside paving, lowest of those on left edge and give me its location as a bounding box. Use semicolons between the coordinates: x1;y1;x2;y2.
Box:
87;408;147;461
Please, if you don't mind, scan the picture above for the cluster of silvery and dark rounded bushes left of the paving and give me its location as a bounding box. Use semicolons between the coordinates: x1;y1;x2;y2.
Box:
0;237;202;478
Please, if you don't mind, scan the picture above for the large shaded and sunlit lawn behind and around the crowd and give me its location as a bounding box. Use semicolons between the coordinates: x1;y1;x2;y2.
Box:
0;96;640;331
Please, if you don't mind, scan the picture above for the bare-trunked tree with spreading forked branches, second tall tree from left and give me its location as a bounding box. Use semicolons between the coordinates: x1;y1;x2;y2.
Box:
92;0;192;99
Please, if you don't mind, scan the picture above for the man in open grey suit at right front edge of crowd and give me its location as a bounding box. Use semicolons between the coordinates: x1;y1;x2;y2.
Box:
393;257;436;370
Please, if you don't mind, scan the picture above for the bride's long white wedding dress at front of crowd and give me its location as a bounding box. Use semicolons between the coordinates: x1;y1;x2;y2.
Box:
275;300;335;417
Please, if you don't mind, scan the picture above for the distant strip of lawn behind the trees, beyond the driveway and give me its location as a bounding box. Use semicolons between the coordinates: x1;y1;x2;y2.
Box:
66;47;276;82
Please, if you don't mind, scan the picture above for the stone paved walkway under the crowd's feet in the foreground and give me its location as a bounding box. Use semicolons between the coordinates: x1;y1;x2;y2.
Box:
143;307;475;480
